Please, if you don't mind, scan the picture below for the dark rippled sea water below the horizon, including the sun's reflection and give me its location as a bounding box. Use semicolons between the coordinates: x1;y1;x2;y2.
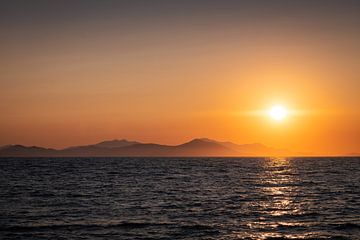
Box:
0;157;360;239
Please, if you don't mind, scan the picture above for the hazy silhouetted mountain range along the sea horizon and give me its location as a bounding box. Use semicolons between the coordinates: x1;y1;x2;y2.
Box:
0;138;296;157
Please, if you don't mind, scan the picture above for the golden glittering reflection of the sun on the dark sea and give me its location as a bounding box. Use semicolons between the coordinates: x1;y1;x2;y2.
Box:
232;157;312;239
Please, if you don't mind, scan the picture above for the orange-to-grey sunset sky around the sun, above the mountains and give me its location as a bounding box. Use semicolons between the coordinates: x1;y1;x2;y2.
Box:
0;0;360;154
